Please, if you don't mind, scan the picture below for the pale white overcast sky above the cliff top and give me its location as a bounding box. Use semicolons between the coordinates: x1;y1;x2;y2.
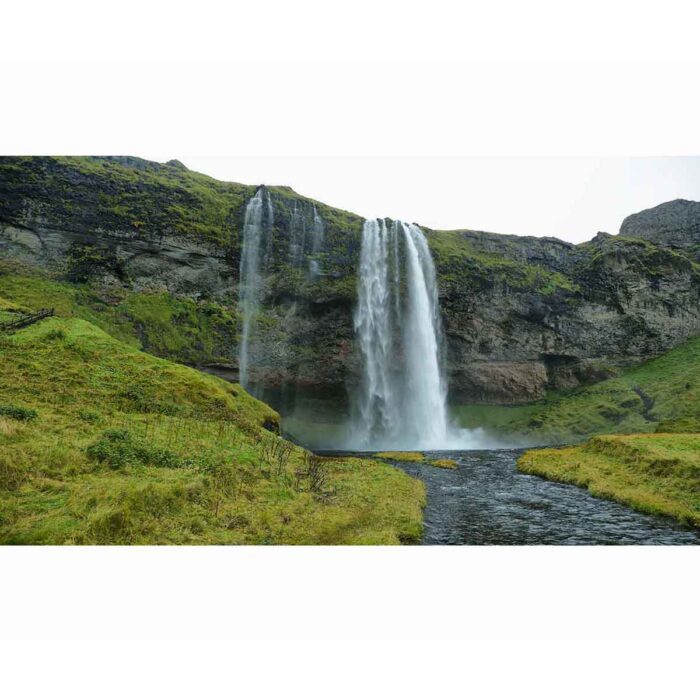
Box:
176;153;700;242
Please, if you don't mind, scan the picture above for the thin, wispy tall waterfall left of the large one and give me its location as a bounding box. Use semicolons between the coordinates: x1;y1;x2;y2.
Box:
238;187;274;388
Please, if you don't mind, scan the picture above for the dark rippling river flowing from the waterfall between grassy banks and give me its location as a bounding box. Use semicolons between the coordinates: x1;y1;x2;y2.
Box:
386;450;700;545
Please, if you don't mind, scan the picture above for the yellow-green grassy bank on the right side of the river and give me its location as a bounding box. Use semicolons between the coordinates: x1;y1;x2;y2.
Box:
518;434;700;527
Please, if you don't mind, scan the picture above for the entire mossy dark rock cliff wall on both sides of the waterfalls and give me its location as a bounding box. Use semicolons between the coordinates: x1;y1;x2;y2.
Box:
0;152;700;408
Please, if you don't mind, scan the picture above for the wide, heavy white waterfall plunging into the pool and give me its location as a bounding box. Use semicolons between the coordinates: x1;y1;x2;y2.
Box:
350;219;448;449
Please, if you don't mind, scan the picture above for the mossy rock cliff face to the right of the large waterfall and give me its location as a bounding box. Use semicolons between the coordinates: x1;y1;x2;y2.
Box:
434;233;700;403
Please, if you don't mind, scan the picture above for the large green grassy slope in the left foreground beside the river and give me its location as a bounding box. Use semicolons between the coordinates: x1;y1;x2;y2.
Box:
0;318;424;544
